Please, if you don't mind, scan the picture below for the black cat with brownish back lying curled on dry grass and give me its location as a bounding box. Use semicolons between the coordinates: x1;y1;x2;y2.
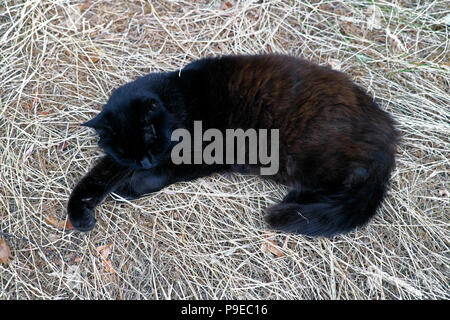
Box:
68;55;398;236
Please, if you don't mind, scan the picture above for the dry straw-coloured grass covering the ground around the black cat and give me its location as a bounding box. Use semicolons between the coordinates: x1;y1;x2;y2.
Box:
0;0;450;299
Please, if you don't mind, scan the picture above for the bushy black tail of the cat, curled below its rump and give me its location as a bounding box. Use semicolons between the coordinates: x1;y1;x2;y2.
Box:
265;159;390;237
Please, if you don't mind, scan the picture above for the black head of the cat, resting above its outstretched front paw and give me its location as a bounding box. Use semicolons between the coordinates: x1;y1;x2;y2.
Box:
82;91;174;170
